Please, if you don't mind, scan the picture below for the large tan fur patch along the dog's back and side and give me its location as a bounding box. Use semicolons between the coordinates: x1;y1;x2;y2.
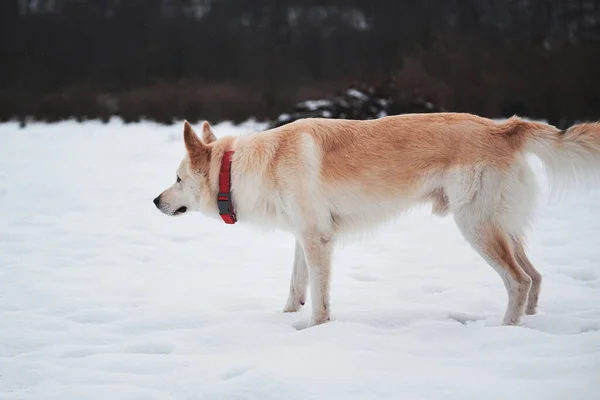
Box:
318;114;522;185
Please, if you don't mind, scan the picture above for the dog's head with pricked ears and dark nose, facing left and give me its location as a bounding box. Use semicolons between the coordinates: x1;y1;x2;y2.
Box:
154;121;216;215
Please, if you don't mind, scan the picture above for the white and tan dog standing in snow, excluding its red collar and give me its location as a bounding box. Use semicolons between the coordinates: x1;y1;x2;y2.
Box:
154;113;600;326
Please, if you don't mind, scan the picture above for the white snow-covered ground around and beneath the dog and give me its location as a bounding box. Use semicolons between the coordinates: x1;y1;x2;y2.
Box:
0;121;600;400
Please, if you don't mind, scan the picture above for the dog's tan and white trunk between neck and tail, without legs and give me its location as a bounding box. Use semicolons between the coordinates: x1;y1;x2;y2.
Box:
264;113;544;233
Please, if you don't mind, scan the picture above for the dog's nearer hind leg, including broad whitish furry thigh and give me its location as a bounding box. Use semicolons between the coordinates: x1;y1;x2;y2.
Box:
447;164;533;325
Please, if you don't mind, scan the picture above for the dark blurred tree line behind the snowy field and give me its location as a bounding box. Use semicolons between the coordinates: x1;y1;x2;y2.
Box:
0;0;600;127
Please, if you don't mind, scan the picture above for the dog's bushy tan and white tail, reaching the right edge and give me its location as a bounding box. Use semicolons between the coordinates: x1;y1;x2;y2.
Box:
518;116;600;191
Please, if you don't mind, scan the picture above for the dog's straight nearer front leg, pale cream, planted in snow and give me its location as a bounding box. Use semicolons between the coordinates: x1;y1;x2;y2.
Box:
302;230;333;327
